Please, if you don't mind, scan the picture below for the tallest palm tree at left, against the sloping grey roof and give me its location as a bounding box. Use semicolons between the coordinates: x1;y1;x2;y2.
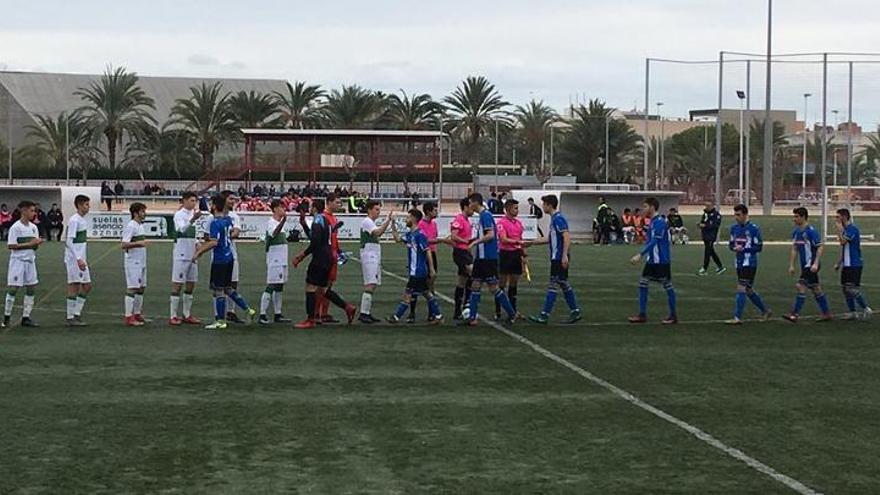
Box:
74;67;156;169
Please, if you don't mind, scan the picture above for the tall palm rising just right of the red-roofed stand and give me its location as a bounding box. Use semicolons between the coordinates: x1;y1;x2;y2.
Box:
443;76;509;168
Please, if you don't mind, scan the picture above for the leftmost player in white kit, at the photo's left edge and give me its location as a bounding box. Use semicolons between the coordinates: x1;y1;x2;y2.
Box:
2;201;43;328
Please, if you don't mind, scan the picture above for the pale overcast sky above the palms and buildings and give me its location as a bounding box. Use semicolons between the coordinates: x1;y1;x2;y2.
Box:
0;0;880;127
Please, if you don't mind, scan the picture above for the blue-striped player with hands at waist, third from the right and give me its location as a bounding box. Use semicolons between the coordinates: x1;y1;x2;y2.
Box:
725;204;771;325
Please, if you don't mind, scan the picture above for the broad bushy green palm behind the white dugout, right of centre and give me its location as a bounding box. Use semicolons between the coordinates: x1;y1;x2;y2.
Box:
560;100;641;181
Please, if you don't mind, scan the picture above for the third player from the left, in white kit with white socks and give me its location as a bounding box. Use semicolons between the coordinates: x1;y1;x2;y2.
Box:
122;203;147;327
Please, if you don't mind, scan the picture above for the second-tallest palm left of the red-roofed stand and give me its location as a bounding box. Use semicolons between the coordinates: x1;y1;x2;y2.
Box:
169;82;237;171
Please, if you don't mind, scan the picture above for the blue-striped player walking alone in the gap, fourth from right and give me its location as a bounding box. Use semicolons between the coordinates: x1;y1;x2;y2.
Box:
629;198;678;325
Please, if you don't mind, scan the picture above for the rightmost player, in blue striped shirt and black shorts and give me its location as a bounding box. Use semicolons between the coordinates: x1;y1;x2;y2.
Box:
834;208;873;320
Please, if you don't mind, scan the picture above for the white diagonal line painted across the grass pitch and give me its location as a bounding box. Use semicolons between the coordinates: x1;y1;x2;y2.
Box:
354;258;821;495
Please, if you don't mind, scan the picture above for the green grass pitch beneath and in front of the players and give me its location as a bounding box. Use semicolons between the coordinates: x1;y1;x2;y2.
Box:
0;242;880;494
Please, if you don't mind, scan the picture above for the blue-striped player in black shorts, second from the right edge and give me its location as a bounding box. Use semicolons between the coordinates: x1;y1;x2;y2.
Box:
783;206;833;323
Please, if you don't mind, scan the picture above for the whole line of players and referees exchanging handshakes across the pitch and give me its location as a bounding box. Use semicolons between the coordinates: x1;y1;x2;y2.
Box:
2;191;872;329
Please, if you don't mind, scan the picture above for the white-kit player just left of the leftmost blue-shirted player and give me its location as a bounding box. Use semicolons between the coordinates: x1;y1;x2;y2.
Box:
168;191;202;326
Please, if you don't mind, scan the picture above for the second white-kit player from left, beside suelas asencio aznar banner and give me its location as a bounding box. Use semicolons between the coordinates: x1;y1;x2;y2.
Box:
64;194;92;327
